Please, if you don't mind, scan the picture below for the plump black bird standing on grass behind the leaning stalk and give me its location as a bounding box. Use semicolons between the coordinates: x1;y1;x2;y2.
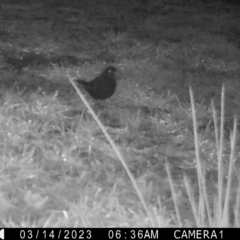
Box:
75;67;117;100
